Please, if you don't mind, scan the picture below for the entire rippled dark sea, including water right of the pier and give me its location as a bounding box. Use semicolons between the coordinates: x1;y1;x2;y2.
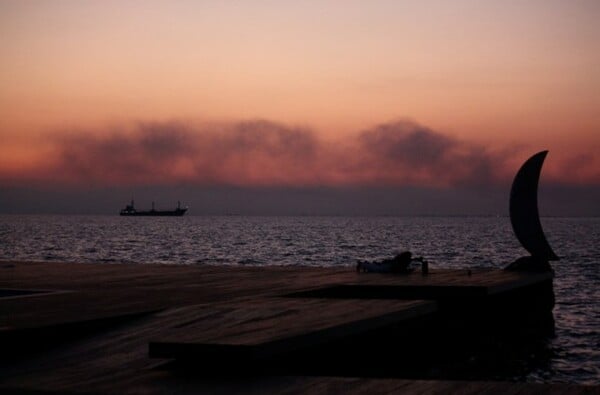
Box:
0;216;600;384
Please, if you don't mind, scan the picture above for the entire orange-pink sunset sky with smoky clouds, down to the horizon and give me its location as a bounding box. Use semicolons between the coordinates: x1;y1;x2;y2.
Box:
0;0;600;215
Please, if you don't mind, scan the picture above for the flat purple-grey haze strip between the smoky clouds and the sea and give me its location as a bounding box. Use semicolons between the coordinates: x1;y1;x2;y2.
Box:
0;186;600;216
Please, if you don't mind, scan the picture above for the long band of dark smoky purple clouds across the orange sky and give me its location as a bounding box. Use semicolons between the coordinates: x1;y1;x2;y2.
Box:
9;120;599;189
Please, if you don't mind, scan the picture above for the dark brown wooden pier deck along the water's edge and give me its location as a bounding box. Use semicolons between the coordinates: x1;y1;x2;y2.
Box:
0;262;599;394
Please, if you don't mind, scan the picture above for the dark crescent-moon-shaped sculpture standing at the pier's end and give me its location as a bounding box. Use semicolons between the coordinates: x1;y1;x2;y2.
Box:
509;151;558;261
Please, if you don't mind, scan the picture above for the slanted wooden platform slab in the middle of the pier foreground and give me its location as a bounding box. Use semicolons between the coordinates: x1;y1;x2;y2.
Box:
149;298;437;363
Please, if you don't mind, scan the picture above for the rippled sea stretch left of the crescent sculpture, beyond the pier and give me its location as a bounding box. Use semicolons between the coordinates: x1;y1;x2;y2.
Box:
0;216;523;267
